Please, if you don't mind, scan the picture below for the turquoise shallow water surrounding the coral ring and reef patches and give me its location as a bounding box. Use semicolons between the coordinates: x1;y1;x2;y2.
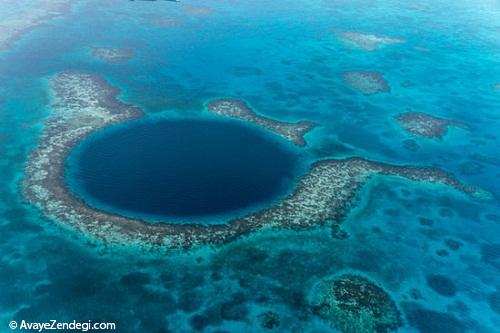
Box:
0;0;500;332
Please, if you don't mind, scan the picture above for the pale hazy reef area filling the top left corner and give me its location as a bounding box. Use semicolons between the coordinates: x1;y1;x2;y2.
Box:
0;0;73;50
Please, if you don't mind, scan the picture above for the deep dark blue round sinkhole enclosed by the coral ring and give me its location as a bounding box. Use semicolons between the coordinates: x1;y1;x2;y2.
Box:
66;119;298;222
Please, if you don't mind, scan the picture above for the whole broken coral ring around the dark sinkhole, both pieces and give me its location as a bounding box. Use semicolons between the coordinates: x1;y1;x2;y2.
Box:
22;72;484;250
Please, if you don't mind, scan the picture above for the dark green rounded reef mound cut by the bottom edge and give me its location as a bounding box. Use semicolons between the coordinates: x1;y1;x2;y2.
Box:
311;274;403;333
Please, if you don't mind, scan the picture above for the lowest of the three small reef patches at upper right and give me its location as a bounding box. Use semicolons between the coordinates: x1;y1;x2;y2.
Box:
396;112;466;138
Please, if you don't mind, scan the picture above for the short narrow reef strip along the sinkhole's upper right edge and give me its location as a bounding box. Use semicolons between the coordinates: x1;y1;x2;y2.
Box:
207;99;317;147
